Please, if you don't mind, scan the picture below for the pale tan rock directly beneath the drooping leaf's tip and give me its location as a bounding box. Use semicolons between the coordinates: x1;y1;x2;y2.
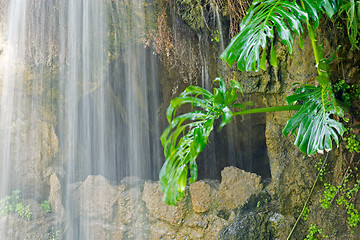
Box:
142;182;184;225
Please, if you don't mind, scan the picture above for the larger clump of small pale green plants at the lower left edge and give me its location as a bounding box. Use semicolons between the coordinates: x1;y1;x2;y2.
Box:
0;190;32;220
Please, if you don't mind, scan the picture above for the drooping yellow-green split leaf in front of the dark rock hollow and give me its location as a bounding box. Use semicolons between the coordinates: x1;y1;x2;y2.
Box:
159;78;245;205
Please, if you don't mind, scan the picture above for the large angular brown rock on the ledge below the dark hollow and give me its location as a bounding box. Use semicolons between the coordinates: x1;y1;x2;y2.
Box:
217;167;263;209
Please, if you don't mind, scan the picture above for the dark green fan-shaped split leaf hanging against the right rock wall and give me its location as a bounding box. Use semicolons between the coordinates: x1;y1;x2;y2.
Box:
283;84;345;155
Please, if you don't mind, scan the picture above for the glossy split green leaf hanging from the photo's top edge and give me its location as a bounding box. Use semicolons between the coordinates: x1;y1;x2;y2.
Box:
220;0;307;71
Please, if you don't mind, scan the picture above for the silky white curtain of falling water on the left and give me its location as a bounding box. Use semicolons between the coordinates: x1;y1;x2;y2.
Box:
0;0;162;239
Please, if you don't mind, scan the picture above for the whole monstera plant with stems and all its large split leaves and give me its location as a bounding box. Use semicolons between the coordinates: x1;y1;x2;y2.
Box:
159;0;360;205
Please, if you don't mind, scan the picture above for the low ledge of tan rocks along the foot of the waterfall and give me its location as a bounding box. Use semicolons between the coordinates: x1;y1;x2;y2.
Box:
39;167;262;240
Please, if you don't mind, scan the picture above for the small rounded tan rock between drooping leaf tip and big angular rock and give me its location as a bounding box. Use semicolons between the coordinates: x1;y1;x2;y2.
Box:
189;181;215;213
